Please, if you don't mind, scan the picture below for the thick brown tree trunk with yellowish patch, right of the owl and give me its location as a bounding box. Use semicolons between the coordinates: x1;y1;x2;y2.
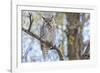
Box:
66;13;83;60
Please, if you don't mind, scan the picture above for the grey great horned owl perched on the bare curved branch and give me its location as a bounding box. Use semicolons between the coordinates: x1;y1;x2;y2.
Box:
40;16;56;60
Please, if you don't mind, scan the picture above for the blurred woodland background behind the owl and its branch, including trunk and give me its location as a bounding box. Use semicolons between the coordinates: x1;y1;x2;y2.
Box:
21;10;90;62
